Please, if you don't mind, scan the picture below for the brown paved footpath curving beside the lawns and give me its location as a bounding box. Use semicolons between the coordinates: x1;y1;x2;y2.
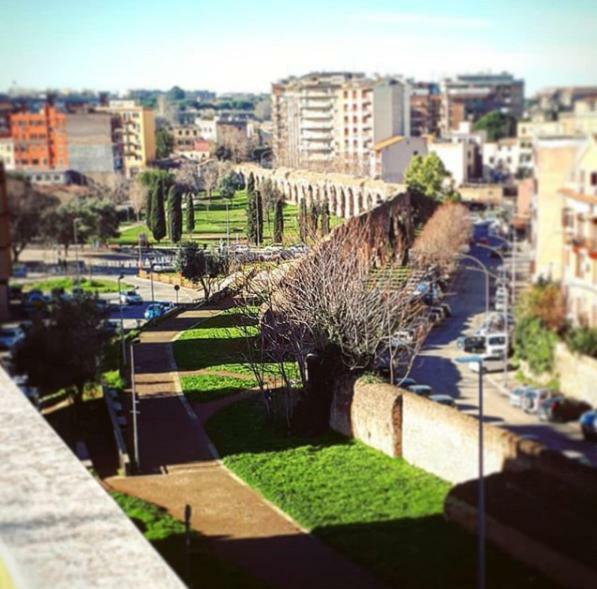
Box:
107;308;383;589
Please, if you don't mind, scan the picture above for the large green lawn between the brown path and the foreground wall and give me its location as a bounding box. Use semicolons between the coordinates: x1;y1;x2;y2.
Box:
207;399;551;589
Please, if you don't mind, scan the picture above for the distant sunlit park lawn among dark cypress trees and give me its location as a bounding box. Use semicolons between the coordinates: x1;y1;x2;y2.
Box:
114;190;341;245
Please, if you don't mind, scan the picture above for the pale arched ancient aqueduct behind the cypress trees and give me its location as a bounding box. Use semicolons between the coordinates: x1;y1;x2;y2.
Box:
236;164;406;219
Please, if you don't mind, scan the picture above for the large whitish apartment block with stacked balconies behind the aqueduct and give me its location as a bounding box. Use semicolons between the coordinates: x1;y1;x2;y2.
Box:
272;72;410;175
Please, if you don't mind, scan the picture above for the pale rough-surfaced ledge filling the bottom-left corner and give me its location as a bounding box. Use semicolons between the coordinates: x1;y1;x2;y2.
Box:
0;368;184;589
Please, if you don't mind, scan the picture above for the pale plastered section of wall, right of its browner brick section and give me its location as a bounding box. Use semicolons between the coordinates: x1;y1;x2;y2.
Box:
402;392;519;483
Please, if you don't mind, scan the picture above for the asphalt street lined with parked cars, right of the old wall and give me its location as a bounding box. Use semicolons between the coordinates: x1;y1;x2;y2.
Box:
411;232;597;467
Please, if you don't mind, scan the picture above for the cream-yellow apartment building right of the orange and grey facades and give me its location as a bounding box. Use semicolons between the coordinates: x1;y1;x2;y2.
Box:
97;100;155;177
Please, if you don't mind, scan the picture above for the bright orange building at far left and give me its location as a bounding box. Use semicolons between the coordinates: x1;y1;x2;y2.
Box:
10;104;68;170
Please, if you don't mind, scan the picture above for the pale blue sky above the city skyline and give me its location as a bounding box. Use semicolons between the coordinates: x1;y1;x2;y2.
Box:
0;0;597;95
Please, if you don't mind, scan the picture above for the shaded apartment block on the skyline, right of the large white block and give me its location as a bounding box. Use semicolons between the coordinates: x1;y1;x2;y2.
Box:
440;72;524;134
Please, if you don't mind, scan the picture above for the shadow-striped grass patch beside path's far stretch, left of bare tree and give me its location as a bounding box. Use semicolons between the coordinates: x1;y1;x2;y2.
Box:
174;309;296;402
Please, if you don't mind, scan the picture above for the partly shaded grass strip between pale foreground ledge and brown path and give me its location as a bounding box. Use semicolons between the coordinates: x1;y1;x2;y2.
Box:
112;493;265;589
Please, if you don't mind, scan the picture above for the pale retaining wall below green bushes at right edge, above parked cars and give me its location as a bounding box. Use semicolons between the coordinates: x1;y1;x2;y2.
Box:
555;343;597;406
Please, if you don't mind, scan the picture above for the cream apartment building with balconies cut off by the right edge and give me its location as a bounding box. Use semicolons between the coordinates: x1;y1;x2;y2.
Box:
559;137;597;327
